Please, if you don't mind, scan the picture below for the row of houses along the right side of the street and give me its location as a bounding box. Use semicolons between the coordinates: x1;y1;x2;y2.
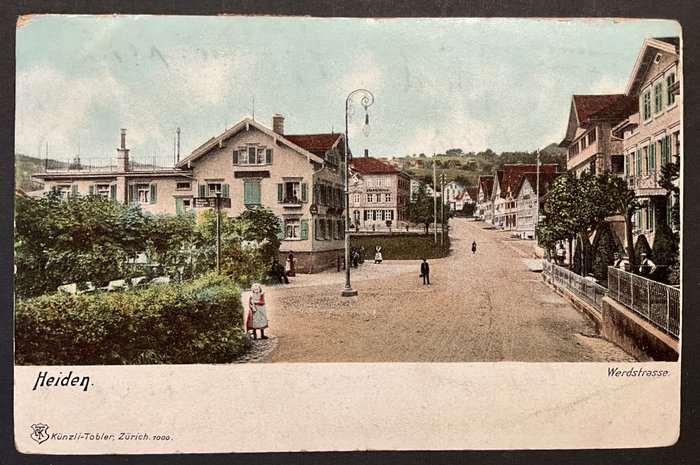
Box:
470;37;682;250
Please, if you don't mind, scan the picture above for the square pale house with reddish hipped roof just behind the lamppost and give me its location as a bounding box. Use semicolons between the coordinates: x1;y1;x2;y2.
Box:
349;153;411;230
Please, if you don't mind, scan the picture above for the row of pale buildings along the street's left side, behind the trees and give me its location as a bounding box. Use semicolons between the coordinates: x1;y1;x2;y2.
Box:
34;115;411;272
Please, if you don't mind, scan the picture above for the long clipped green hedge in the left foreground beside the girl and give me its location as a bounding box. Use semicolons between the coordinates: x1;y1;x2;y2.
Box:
15;275;247;365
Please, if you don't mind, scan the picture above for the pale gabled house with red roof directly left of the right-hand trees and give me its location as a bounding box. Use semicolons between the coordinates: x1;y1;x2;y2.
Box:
513;172;562;239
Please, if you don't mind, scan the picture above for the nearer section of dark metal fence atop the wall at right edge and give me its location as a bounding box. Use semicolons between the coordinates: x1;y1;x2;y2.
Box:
608;266;681;338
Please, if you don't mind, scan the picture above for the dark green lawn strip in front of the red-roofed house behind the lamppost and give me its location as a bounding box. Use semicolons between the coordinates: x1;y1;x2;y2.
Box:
350;234;450;260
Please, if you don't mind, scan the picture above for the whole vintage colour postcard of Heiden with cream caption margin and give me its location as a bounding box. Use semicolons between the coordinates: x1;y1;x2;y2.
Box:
14;15;684;454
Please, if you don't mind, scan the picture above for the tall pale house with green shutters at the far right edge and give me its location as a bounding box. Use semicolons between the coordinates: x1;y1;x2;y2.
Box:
613;37;682;244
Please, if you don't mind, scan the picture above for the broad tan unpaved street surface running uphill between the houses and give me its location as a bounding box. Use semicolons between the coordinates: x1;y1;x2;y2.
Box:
252;219;634;362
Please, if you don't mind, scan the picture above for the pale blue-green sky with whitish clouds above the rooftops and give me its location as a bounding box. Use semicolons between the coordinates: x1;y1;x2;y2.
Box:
15;15;681;162
